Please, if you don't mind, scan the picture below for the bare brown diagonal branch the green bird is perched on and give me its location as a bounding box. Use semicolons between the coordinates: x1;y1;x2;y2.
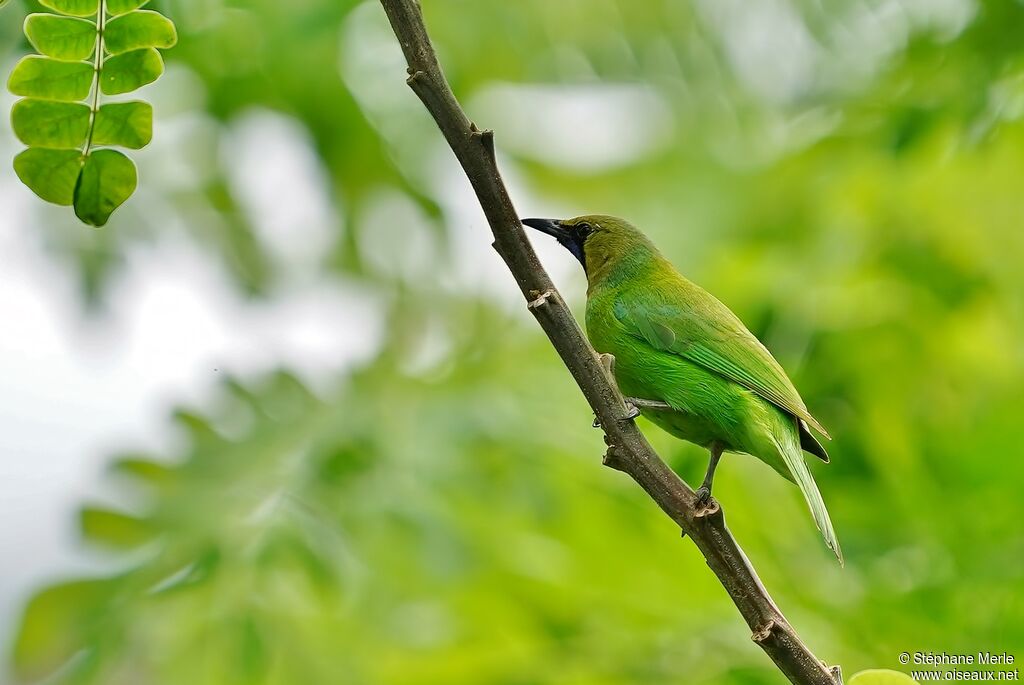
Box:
381;0;842;685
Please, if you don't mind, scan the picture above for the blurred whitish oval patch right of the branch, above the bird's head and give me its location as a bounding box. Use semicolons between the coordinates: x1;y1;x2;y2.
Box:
467;83;675;172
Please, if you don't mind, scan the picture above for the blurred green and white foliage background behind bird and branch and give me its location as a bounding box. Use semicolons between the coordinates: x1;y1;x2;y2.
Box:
0;0;1024;685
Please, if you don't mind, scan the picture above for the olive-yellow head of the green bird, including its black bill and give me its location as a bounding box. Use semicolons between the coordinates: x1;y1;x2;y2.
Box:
522;214;654;281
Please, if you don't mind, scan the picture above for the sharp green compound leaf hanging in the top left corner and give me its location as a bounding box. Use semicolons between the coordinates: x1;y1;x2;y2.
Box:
8;0;177;227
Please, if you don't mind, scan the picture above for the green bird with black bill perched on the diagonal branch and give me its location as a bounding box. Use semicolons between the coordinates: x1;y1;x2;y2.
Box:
522;215;843;563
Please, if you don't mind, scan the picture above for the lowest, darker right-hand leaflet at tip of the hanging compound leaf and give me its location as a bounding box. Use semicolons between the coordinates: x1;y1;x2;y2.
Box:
75;149;138;227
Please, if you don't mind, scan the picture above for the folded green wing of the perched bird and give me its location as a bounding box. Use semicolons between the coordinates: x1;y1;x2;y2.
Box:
614;282;830;437
